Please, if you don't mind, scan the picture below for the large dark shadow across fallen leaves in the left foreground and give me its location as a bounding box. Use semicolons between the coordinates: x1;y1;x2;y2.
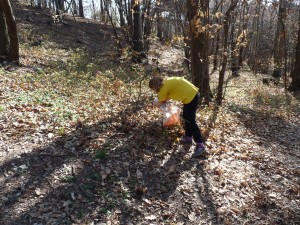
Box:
0;99;218;225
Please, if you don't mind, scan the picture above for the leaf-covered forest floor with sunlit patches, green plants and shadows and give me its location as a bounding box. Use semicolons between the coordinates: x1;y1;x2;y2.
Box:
0;1;300;225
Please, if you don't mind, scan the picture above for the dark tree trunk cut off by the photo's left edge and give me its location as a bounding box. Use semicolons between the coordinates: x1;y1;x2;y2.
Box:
0;3;9;59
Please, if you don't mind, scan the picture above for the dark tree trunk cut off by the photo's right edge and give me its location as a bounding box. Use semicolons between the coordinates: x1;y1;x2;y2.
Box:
289;8;300;91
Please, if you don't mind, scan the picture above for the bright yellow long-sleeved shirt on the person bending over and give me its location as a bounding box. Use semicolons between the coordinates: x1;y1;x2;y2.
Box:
157;77;199;104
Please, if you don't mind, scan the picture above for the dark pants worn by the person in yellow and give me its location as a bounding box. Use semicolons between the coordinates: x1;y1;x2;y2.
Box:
183;93;203;143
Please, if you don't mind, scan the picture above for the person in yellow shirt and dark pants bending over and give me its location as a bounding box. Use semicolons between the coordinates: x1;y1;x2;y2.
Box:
149;77;205;157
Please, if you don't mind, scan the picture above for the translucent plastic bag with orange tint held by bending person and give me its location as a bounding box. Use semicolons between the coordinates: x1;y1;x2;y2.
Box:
160;104;180;127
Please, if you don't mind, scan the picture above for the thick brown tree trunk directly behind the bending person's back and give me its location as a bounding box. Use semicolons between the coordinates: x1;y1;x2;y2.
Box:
187;0;211;101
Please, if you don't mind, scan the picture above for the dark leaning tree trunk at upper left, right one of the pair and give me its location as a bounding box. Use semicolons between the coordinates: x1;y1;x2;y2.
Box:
0;0;19;63
